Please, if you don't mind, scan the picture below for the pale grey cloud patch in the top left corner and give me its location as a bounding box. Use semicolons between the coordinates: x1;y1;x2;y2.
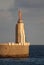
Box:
0;0;15;9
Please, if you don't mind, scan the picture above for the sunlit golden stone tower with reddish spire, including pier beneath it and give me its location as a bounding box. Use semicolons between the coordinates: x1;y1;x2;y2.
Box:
0;10;30;58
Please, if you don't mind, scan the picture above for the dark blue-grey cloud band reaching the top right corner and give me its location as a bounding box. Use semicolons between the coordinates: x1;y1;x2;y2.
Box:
16;0;44;8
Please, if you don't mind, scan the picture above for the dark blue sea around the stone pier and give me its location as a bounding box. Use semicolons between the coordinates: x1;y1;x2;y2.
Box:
0;45;44;65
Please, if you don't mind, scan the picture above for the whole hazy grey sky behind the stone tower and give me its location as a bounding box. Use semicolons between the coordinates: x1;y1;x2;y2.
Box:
0;0;44;45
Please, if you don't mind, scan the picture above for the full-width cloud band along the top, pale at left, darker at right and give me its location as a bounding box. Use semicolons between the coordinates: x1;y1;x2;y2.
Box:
0;0;44;10
